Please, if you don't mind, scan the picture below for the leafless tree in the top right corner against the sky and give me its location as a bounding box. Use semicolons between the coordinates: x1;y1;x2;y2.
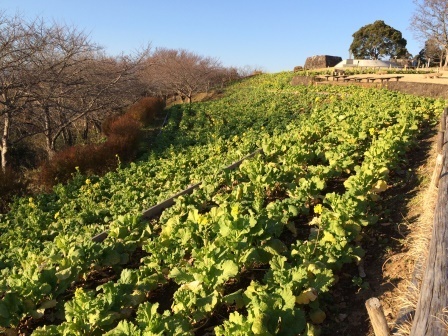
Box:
410;0;448;66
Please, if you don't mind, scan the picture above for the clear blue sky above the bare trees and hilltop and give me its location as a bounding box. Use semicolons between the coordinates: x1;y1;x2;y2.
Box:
0;0;422;72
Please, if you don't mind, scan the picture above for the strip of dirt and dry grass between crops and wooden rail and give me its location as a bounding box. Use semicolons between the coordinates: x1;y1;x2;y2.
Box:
322;128;435;336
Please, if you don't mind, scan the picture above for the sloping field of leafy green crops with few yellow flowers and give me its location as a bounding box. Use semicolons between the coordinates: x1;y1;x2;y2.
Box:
0;73;443;335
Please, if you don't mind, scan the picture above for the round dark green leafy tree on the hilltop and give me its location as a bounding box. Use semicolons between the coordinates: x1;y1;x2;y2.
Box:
350;20;408;59
